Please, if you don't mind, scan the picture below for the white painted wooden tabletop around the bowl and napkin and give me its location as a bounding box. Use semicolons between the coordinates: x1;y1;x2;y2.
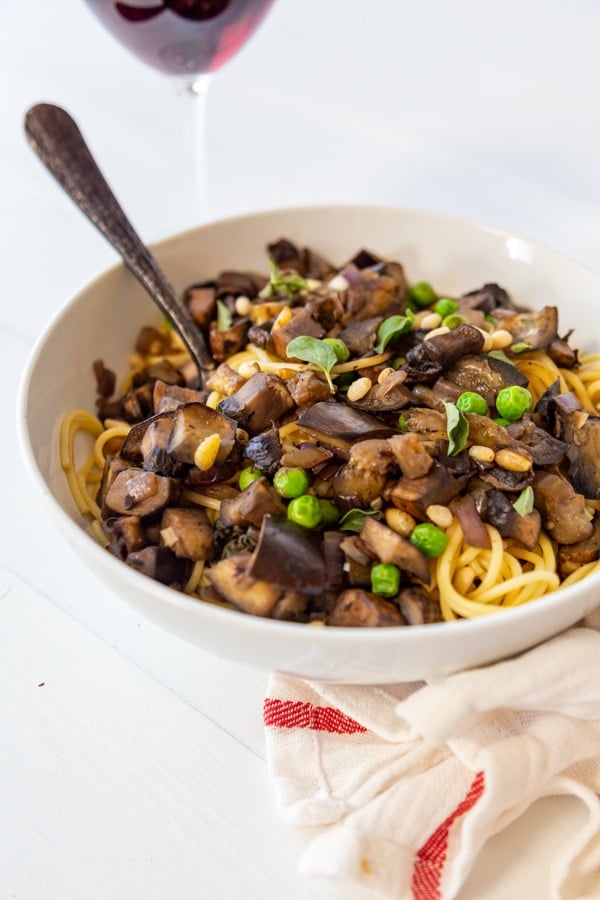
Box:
0;0;600;900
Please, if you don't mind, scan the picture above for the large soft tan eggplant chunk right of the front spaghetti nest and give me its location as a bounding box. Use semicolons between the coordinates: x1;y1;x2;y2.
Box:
533;472;594;544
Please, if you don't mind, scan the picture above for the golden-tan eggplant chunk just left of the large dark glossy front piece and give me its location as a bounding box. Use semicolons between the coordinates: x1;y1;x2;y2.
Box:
206;553;284;616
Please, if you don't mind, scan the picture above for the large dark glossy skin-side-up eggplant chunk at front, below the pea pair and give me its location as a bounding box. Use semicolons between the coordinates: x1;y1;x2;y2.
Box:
248;515;326;595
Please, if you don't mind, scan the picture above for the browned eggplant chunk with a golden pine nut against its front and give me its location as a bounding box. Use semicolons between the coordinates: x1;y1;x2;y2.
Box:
167;403;237;465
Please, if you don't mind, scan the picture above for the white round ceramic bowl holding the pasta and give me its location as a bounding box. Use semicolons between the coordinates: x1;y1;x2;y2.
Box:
19;206;600;684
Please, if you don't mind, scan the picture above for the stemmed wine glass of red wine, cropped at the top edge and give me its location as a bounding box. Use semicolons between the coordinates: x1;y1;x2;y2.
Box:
85;0;275;224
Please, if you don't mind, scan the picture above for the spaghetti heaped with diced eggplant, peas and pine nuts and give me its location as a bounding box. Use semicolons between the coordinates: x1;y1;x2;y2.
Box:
61;239;600;626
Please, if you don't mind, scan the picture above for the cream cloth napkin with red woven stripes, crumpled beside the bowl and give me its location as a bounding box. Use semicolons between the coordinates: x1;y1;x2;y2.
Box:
264;611;600;900
